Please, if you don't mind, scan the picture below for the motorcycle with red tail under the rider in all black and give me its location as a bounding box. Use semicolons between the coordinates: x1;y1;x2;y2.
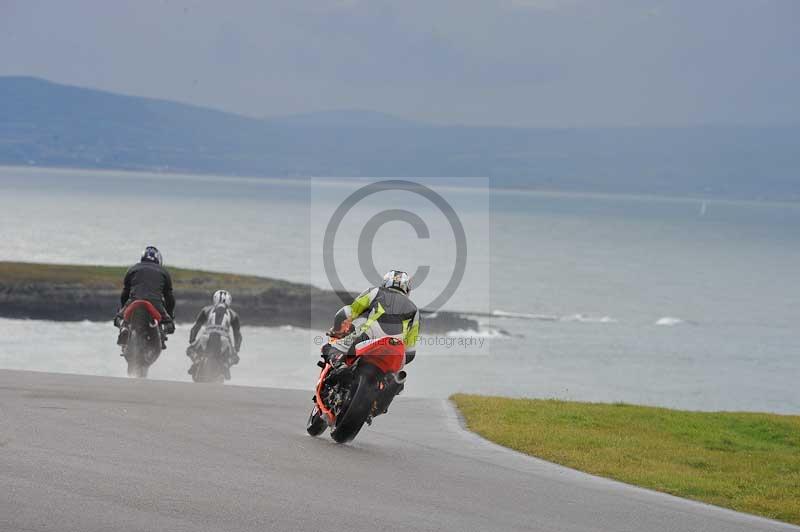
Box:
122;300;164;378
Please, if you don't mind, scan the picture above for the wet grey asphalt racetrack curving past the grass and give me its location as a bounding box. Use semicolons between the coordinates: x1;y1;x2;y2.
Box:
0;371;800;532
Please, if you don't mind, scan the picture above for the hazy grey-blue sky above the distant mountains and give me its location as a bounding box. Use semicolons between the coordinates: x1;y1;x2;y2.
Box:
0;0;800;126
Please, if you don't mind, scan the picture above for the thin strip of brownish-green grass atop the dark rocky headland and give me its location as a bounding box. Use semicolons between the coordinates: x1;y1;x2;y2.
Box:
0;261;306;292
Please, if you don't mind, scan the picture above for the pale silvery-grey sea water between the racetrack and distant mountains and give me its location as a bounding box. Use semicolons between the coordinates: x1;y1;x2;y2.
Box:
0;168;800;413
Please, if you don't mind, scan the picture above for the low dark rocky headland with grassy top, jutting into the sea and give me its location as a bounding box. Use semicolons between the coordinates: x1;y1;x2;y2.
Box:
0;262;478;334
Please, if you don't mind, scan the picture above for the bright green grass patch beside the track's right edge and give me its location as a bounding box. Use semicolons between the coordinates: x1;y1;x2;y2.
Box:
452;394;800;524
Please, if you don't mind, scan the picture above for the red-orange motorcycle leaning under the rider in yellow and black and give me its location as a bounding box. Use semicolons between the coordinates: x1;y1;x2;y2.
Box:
306;333;406;443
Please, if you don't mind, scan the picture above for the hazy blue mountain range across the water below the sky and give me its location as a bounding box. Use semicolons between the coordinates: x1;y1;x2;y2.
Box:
0;77;800;200
